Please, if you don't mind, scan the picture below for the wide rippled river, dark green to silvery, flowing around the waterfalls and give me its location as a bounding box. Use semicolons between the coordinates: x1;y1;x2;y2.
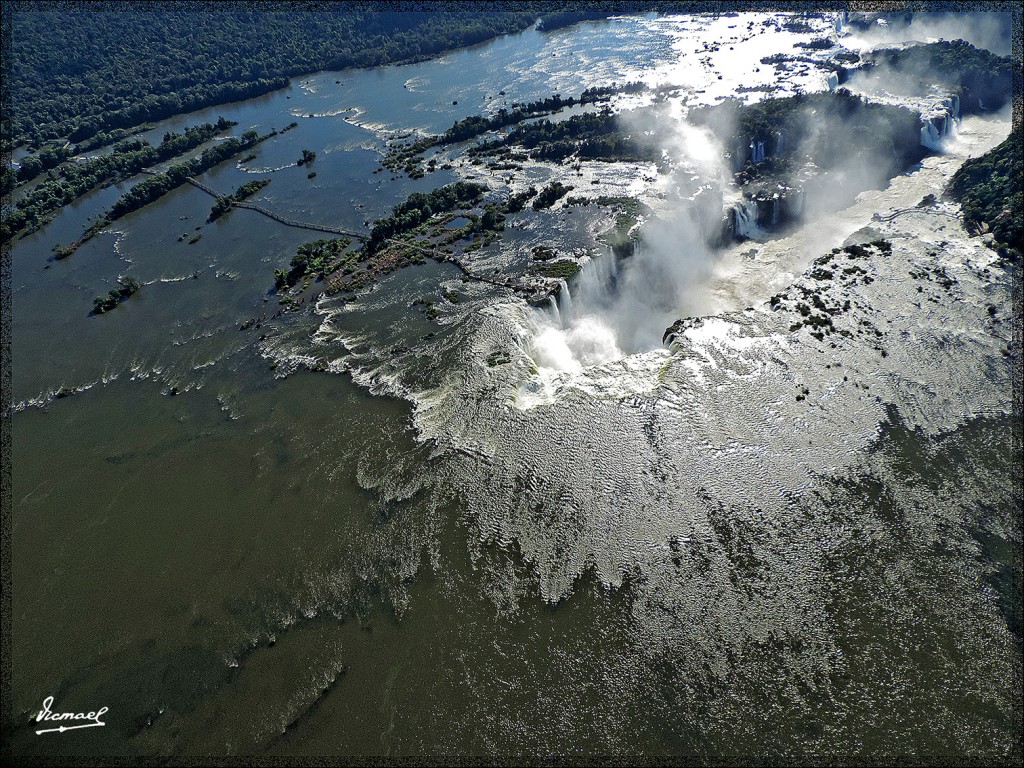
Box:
4;14;1021;761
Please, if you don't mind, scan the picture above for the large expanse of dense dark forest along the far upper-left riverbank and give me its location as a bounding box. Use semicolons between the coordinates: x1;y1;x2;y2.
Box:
5;9;561;146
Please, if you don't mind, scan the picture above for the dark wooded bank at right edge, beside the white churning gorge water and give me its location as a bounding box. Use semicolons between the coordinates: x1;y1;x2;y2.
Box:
949;126;1024;258
